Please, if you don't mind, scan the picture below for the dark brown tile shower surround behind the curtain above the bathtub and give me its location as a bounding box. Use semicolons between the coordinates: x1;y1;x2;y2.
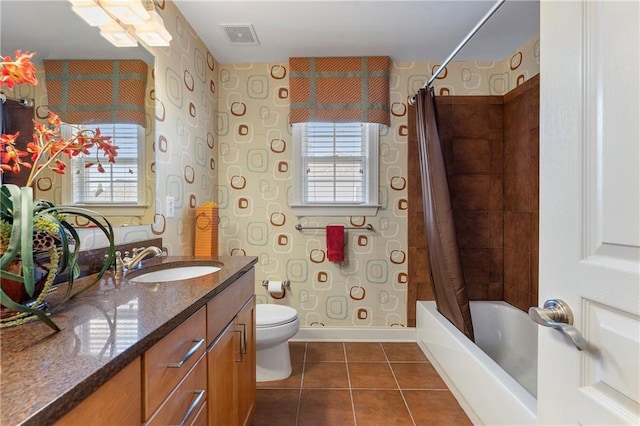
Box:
407;75;539;326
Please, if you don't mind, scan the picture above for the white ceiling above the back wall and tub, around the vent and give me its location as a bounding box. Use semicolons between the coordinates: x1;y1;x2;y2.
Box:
175;0;540;63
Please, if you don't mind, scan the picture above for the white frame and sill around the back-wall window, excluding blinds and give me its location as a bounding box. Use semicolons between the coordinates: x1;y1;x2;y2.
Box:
290;123;380;217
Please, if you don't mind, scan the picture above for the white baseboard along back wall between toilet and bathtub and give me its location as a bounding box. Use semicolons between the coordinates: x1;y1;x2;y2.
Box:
290;327;416;342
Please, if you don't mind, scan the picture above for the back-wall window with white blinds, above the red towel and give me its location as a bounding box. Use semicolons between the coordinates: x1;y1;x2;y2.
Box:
292;123;379;216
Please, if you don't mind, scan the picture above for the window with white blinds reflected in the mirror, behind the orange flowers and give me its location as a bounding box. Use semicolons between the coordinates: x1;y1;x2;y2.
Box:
62;123;146;215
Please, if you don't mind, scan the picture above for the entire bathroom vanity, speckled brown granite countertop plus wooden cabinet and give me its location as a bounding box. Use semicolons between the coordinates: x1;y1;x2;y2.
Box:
0;256;257;425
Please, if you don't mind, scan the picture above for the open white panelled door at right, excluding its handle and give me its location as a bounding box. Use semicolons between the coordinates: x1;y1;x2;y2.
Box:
538;0;640;425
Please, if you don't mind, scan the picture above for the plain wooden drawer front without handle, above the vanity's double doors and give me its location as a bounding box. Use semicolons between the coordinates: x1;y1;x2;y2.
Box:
207;268;255;346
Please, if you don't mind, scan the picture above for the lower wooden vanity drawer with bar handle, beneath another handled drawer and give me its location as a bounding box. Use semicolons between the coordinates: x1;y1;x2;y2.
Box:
147;356;207;426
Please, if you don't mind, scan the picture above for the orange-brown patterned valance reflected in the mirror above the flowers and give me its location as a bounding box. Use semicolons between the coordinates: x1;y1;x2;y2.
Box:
44;60;147;127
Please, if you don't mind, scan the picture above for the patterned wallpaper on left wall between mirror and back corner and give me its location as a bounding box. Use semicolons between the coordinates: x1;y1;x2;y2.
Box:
148;1;218;255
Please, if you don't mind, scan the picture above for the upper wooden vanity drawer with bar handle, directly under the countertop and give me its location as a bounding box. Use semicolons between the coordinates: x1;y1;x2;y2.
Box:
142;307;206;419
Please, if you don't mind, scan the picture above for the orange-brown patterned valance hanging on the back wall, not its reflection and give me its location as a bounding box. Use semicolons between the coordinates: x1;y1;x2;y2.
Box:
289;56;390;126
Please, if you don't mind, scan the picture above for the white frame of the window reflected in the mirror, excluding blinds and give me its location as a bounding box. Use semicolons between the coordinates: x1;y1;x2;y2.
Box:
62;123;148;217
